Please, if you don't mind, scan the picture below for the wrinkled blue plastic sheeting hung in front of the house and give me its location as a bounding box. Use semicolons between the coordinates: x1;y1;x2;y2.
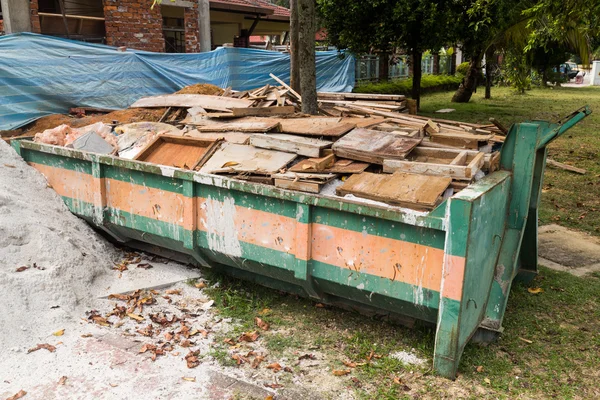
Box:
0;33;354;130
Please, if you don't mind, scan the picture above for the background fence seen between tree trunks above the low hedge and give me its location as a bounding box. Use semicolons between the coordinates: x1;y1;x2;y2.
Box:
356;55;452;82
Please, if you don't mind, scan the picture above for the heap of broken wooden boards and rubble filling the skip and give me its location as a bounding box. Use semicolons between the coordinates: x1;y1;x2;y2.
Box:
23;75;505;210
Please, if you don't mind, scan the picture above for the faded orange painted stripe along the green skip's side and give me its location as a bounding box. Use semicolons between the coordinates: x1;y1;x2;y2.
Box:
33;164;465;301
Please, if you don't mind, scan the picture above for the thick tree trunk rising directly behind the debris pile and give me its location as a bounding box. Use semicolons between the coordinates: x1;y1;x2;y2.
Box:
297;0;318;115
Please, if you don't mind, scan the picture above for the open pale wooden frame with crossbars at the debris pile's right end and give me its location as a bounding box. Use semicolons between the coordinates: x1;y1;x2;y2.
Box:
383;147;484;181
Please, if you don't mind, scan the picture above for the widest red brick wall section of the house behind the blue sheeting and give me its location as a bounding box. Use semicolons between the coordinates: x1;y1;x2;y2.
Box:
103;0;165;52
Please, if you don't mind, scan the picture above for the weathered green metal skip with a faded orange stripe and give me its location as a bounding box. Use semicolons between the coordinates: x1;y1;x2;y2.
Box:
12;107;590;379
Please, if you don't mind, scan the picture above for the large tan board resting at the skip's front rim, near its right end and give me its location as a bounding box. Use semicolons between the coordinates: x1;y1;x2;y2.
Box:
336;172;452;210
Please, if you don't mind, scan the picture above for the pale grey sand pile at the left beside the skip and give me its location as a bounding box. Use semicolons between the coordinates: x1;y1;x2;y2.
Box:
0;140;117;348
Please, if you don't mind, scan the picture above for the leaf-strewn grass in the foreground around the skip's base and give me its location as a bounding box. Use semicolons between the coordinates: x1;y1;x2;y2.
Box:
205;268;600;399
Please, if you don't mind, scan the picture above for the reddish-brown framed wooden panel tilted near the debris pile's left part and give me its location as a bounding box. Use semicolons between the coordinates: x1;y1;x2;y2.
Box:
133;135;220;169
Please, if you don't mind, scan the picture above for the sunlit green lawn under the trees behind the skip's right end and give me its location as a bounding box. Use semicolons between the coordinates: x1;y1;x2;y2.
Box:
420;87;600;235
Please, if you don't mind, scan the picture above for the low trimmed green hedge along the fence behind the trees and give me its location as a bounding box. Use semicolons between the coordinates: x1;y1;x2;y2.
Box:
354;75;462;96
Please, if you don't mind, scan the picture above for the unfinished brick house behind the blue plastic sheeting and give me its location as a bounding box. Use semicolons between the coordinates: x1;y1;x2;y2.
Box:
0;0;290;53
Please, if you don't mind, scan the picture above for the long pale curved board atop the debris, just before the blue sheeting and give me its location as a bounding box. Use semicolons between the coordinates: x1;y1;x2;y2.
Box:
130;94;254;111
